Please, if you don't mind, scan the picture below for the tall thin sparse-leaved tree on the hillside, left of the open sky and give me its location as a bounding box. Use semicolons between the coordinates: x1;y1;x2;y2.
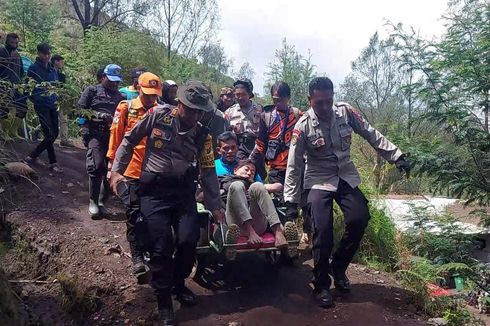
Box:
150;0;219;60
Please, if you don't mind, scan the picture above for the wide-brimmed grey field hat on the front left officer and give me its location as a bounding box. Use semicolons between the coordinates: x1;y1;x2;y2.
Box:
177;80;215;112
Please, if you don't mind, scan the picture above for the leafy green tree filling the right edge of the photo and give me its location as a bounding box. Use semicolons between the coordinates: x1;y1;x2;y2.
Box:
393;0;490;205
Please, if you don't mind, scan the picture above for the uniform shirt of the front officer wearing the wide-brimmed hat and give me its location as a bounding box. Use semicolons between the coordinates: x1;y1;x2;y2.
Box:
112;106;221;209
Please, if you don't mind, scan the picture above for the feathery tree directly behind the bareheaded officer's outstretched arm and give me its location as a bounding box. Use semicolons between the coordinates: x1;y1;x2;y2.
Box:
341;33;407;189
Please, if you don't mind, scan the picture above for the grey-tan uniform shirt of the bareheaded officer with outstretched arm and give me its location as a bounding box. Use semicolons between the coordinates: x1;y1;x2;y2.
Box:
284;102;402;203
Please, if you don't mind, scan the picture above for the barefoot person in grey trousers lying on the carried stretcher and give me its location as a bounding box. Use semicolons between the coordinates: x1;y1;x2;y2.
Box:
220;159;297;248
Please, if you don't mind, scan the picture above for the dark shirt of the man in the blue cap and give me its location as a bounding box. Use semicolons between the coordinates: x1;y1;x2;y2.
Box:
78;84;125;115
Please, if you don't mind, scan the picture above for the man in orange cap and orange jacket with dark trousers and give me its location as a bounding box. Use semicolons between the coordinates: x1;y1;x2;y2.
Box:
107;72;162;283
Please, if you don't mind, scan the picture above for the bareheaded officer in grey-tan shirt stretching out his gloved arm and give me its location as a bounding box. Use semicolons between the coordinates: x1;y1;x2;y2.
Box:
284;77;410;308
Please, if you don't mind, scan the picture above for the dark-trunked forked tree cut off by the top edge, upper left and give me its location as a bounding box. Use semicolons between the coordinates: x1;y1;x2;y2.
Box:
70;0;152;33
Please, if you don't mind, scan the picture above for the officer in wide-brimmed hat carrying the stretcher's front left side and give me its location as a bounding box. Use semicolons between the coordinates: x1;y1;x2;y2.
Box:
111;81;224;325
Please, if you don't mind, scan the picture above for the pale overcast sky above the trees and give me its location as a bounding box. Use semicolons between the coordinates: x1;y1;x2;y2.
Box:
218;0;447;94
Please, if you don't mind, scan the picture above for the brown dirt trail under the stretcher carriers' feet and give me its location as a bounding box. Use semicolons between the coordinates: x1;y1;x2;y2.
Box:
1;143;425;325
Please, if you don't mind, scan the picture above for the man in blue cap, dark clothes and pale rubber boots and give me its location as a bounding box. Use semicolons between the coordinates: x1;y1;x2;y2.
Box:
78;64;124;219
